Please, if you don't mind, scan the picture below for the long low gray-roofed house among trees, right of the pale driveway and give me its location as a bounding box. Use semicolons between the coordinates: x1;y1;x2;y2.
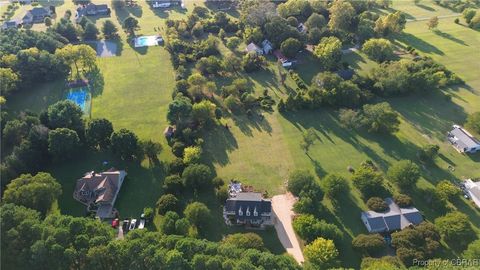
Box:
361;198;423;233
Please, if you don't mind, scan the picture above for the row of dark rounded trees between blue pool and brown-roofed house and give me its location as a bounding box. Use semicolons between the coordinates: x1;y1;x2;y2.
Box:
2;100;162;188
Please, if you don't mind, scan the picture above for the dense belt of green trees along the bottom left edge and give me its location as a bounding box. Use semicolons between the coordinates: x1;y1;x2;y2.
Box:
0;204;300;269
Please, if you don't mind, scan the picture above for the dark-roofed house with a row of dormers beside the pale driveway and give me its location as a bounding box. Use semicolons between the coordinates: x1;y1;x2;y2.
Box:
223;192;272;226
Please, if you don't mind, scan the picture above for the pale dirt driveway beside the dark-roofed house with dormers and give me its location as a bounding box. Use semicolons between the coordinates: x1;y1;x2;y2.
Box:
272;193;305;264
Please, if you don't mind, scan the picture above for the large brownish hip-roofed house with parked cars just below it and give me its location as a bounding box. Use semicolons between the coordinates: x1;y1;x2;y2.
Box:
73;168;127;219
